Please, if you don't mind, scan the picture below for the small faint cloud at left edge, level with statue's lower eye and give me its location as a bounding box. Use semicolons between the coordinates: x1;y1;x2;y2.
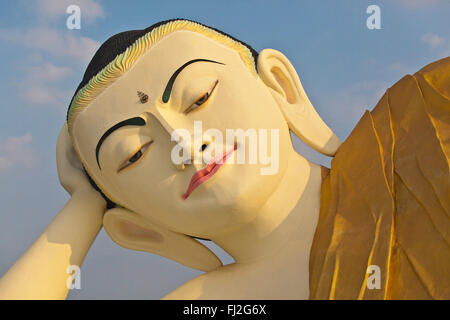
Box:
0;133;36;173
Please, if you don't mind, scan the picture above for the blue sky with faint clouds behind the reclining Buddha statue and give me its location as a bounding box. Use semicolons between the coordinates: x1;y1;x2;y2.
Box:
0;0;450;299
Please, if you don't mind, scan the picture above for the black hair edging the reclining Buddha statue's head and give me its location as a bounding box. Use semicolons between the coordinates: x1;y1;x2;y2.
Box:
67;18;258;209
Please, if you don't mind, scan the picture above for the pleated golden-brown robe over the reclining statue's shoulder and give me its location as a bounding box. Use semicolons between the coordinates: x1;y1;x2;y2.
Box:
310;57;450;299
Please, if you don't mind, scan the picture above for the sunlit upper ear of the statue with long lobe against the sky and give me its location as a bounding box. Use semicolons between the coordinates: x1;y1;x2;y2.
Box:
258;49;341;156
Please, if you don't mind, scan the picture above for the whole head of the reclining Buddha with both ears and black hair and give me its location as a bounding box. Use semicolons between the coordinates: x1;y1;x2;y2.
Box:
67;19;340;270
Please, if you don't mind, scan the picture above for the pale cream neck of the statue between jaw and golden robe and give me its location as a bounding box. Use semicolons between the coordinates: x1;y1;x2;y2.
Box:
212;150;322;263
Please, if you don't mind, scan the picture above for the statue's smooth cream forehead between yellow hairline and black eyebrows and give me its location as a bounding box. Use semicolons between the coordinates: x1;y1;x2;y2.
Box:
72;30;243;158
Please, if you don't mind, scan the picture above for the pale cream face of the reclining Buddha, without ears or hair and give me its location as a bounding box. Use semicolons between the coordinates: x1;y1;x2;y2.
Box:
72;31;293;238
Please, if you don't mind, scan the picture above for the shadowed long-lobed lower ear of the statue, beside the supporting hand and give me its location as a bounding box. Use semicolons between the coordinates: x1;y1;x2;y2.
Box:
103;208;222;271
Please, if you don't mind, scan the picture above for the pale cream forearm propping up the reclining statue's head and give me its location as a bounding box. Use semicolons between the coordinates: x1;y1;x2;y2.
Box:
0;190;105;299
